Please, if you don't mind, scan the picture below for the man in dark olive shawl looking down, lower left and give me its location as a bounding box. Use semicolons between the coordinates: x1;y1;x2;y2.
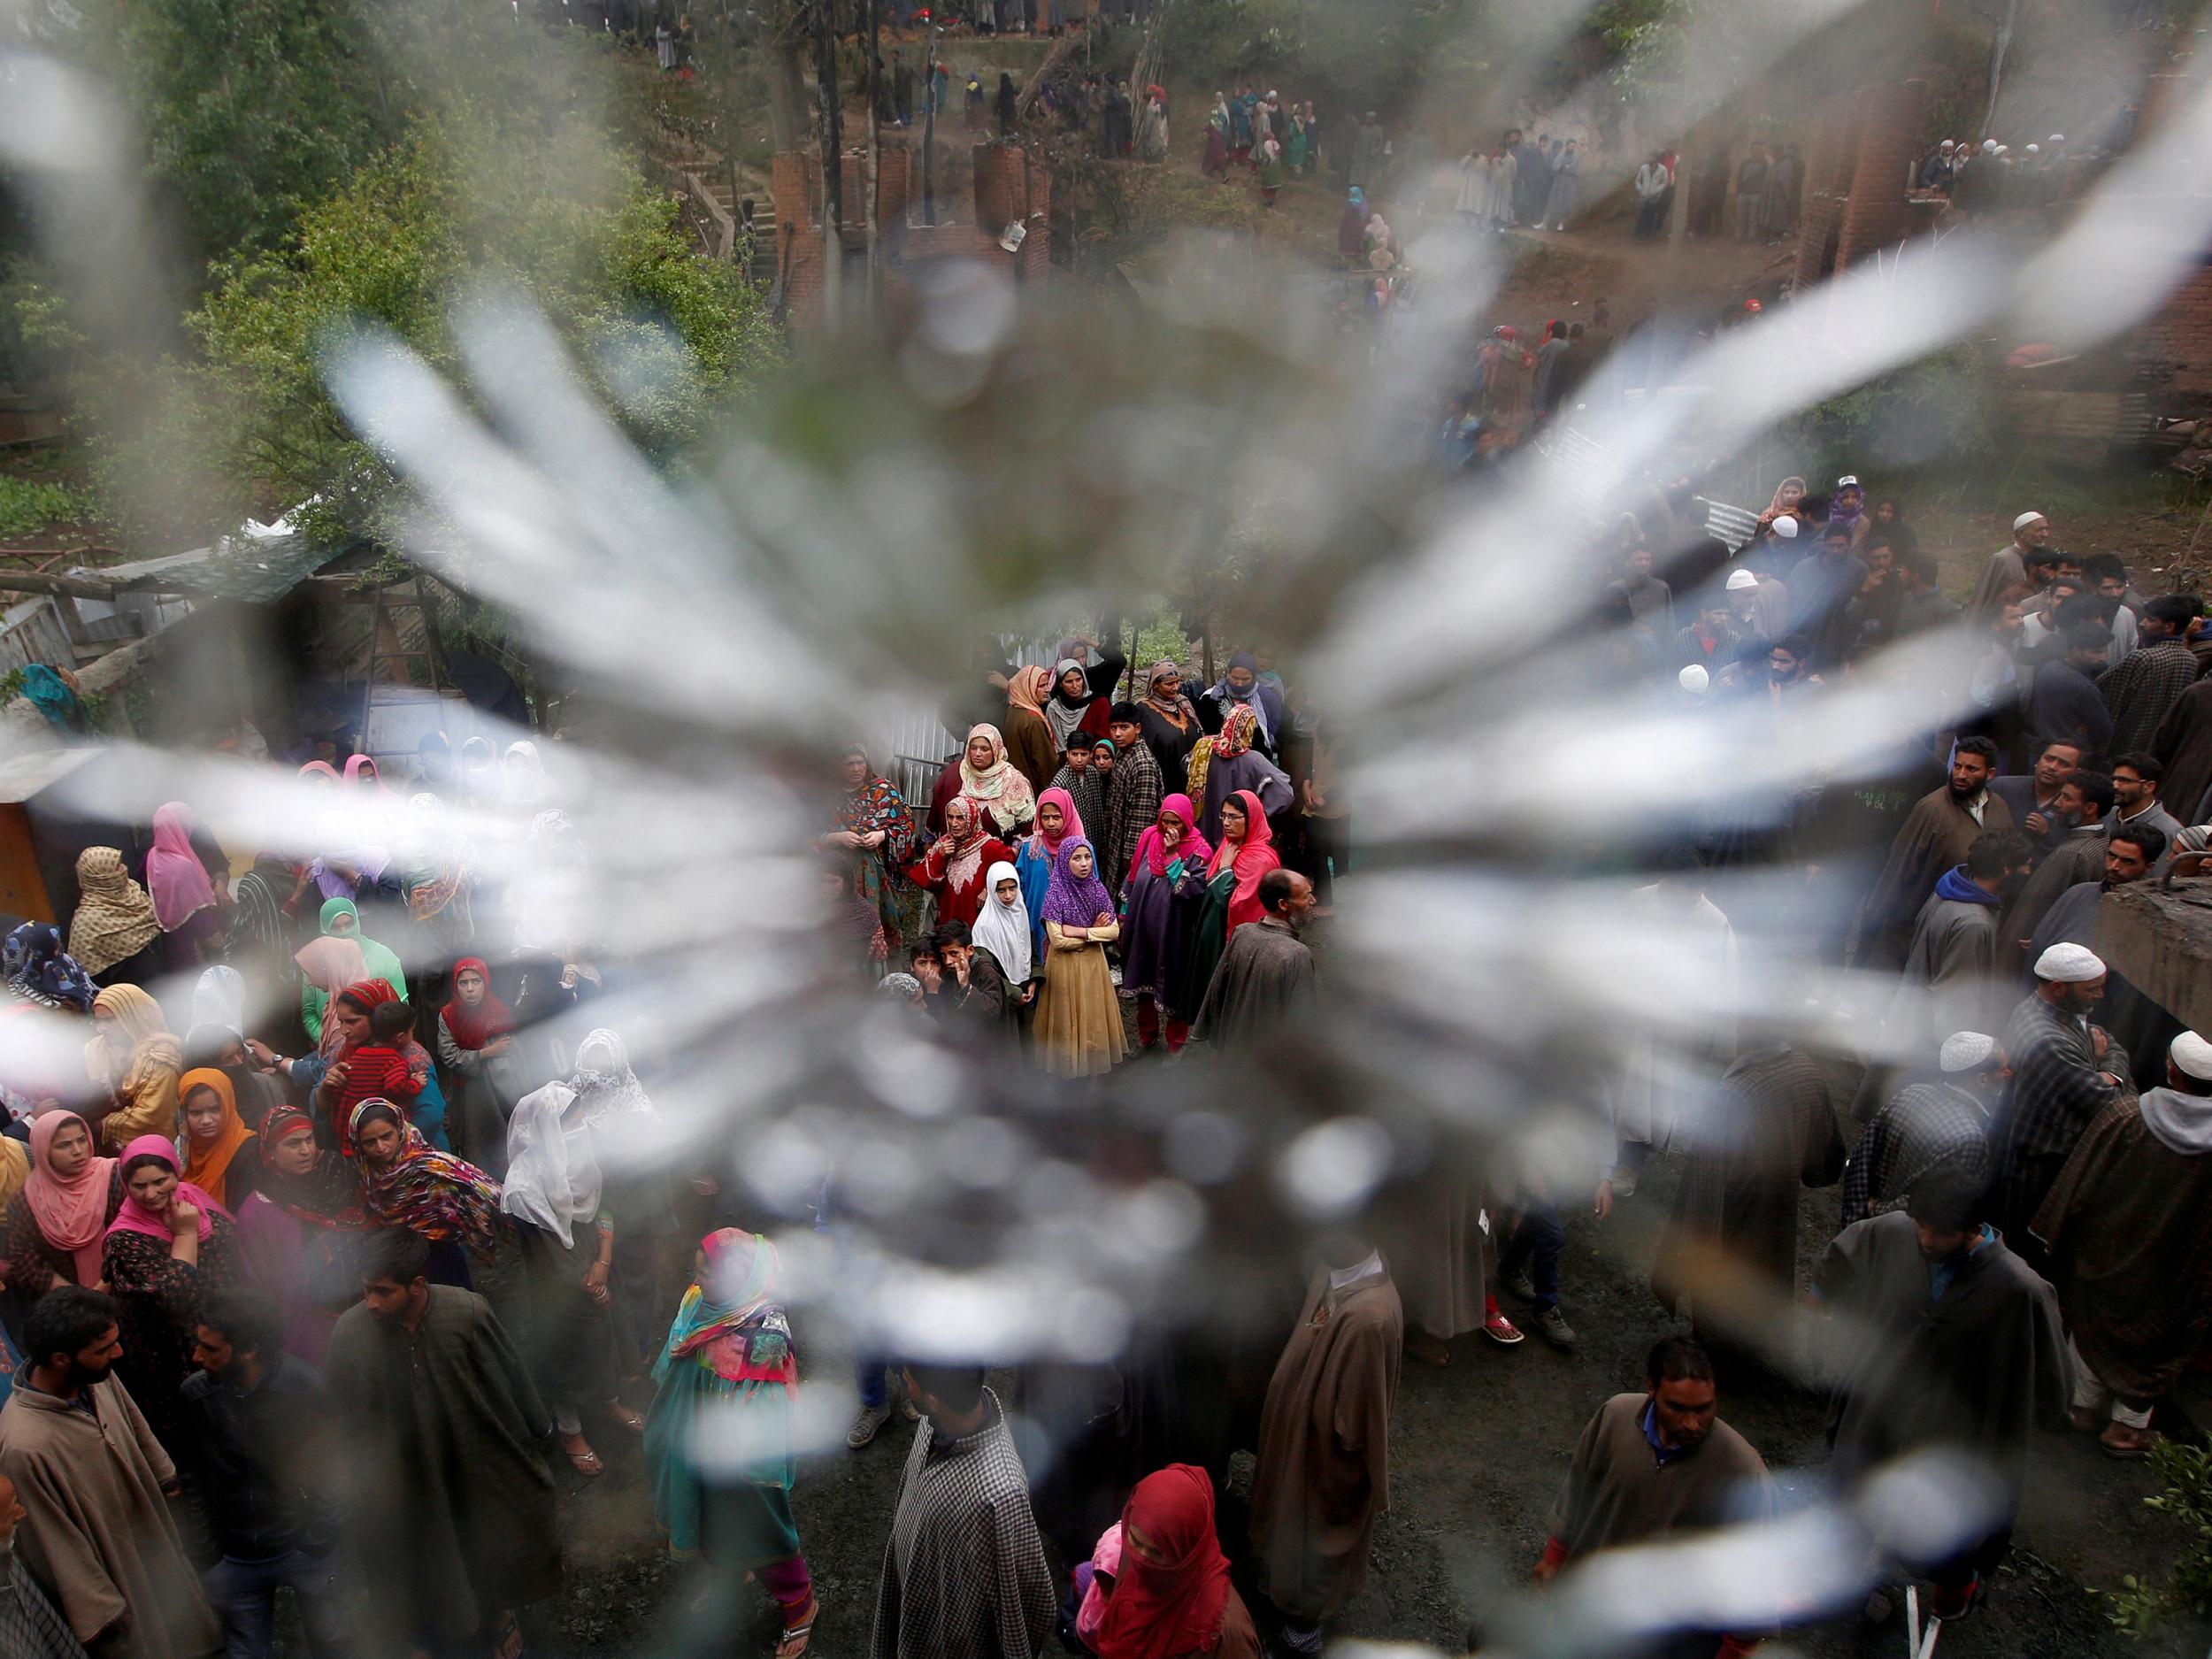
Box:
327;1230;560;1659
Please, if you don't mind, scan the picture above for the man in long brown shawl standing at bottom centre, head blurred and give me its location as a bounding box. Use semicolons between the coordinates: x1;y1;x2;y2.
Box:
1252;1234;1405;1655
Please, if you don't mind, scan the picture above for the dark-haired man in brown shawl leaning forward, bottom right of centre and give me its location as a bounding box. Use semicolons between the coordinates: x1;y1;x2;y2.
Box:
1535;1336;1774;1655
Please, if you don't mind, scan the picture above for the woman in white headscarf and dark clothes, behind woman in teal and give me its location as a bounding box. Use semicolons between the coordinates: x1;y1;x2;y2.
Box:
500;1082;646;1476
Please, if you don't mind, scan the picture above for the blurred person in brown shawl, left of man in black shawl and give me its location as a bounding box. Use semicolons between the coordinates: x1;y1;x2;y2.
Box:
1653;1044;1849;1371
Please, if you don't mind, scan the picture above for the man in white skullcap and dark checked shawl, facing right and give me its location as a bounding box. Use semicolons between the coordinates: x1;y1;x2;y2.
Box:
2000;945;2128;1252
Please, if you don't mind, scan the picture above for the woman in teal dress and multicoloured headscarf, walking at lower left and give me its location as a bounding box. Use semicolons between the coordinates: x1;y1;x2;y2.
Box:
646;1228;818;1655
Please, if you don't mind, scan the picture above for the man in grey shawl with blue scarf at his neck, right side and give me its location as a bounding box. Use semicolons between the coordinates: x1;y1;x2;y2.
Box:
1883;830;2035;1062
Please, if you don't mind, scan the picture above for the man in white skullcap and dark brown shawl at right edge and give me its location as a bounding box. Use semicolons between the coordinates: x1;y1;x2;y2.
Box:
2035;1031;2212;1458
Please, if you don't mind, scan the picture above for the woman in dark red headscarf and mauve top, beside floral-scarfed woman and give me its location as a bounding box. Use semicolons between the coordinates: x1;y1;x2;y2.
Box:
239;1106;367;1365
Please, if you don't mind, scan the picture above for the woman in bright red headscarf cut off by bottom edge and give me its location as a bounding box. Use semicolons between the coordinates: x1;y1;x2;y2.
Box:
1078;1463;1261;1659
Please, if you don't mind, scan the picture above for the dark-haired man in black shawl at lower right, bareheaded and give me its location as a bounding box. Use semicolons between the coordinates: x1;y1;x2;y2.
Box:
1814;1177;2070;1619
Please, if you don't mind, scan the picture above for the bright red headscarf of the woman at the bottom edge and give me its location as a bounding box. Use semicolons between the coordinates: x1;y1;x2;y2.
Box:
1093;1463;1230;1659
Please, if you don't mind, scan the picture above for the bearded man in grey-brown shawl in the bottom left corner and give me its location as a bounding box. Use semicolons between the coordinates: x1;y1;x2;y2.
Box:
0;1286;217;1659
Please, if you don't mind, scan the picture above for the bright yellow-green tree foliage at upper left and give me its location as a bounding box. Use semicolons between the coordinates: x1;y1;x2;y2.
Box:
100;128;781;540
